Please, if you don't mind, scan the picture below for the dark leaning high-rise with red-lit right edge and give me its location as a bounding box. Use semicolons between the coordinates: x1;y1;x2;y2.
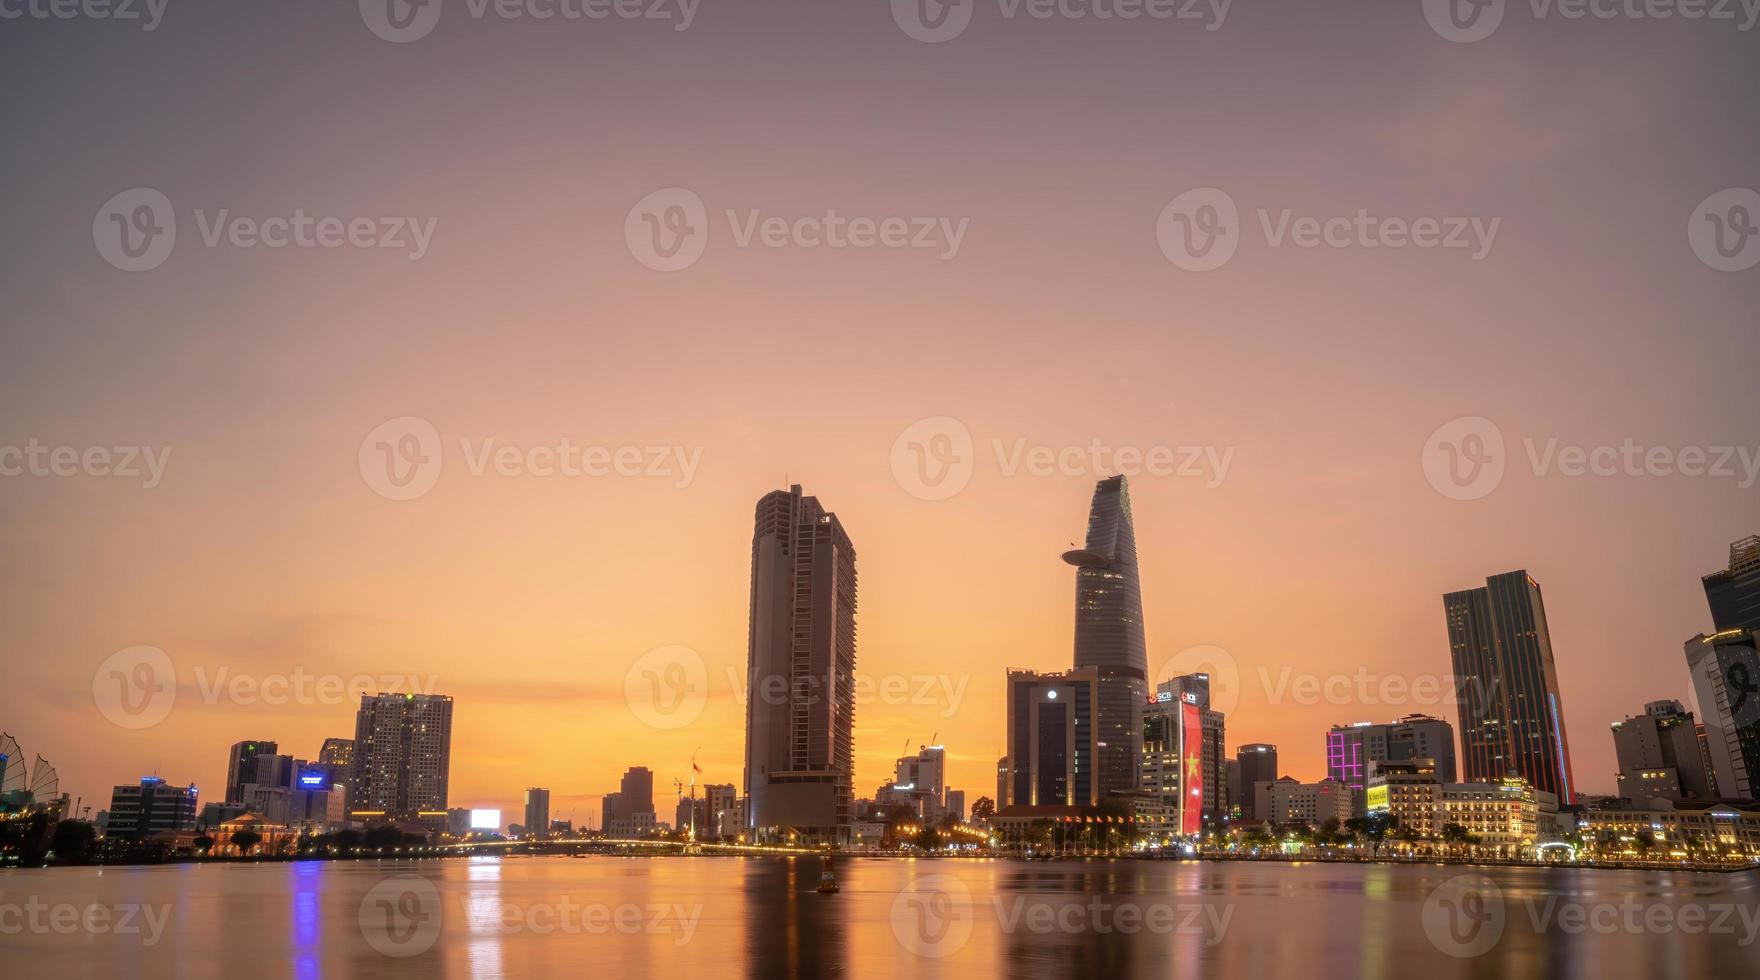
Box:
1443;570;1575;806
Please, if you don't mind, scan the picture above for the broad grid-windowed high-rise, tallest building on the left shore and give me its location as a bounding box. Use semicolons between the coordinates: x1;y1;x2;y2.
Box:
348;693;452;819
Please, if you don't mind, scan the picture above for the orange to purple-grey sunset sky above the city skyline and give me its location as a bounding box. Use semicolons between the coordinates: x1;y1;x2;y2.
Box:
0;0;1760;823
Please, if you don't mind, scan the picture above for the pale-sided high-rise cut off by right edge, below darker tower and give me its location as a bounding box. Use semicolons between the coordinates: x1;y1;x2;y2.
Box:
1686;628;1760;801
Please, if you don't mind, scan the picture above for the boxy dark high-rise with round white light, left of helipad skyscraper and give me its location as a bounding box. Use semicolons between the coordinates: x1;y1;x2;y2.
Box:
1008;667;1098;806
